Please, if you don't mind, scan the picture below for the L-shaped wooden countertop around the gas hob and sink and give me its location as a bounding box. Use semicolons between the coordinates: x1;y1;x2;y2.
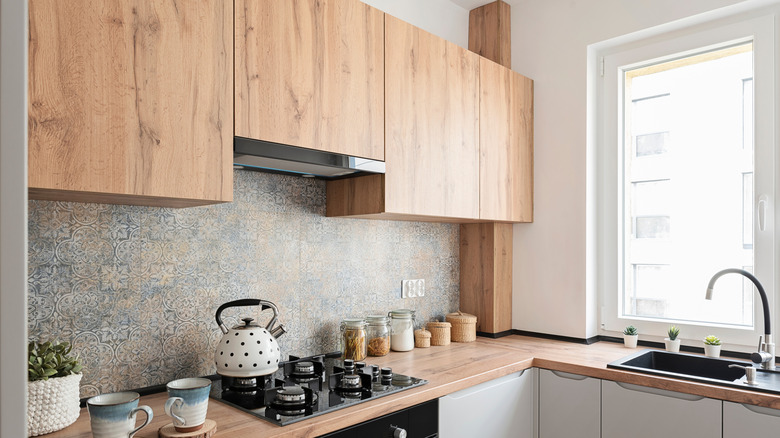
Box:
45;335;780;438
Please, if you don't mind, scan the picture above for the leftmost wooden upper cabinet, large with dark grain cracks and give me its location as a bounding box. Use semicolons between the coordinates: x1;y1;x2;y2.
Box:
29;0;233;207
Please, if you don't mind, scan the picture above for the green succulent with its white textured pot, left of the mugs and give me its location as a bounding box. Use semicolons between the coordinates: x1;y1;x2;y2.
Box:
27;341;81;436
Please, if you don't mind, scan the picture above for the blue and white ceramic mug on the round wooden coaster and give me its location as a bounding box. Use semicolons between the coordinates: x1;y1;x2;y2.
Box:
165;377;211;432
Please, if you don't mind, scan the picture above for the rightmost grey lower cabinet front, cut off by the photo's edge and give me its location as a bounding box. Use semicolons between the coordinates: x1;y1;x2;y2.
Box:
723;401;780;438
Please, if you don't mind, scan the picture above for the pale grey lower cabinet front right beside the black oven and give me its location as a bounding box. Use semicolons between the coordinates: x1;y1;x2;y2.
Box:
439;368;538;438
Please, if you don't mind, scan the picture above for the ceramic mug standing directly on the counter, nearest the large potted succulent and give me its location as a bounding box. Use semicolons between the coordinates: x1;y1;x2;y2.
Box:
87;391;154;438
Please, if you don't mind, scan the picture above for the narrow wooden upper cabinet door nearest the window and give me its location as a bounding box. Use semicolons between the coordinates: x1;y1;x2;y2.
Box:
479;58;534;222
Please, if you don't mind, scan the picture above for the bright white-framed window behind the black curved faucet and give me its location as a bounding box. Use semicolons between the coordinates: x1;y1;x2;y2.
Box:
599;17;778;345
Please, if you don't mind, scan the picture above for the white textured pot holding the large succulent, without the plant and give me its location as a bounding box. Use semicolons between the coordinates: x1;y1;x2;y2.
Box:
27;374;81;436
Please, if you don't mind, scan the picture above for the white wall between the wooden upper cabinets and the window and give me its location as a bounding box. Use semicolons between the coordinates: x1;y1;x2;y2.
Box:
509;0;742;338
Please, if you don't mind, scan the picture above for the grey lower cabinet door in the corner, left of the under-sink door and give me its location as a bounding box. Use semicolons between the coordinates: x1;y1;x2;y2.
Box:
539;370;601;438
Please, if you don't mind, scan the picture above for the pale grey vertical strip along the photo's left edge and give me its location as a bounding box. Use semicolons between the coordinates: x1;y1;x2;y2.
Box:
0;0;27;438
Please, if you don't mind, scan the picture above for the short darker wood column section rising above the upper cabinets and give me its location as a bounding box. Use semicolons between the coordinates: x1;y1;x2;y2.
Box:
469;0;512;68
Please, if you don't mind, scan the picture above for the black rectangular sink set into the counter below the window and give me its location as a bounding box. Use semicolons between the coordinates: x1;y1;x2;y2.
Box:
607;350;780;394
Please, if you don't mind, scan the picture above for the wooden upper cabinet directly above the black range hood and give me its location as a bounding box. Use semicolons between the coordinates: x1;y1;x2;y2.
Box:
235;0;385;160
